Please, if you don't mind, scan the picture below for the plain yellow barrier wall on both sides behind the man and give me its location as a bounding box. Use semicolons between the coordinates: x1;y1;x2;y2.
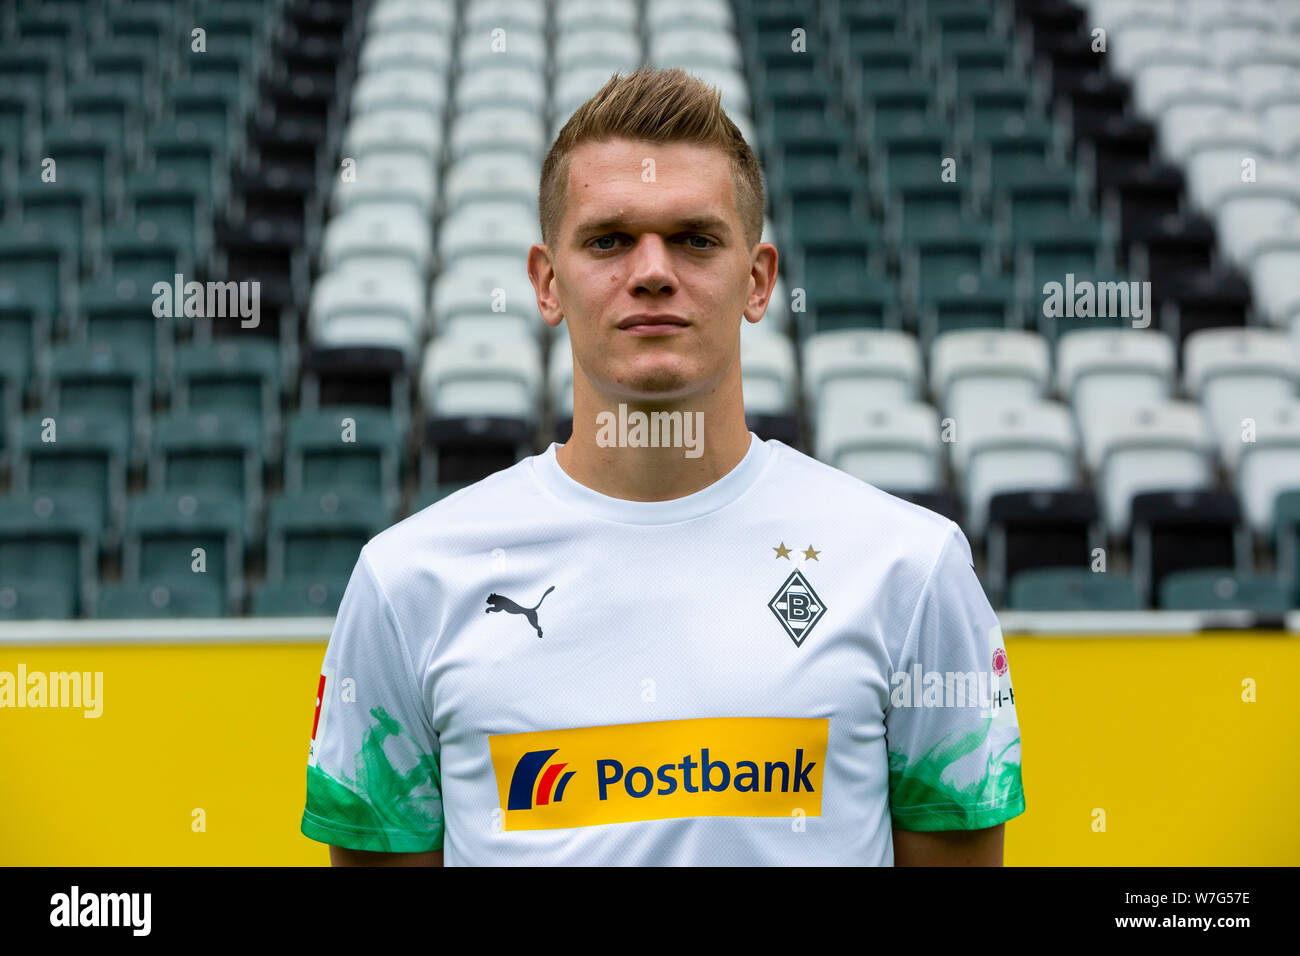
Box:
0;635;1300;866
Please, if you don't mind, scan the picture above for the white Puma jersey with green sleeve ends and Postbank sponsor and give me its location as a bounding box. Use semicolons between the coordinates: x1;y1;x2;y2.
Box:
302;434;1024;866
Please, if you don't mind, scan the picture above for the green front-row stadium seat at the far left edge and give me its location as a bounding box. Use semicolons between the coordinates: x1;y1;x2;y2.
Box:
0;492;101;617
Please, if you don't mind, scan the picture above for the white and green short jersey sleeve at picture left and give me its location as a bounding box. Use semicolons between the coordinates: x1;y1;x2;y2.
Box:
302;550;443;853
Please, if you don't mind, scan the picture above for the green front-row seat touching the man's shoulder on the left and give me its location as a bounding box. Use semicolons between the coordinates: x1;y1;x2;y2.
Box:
267;492;393;584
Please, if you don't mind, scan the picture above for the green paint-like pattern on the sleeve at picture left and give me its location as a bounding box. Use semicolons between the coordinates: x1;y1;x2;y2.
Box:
302;708;443;853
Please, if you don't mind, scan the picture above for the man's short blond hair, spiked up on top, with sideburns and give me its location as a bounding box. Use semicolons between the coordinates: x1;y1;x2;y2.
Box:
537;66;764;248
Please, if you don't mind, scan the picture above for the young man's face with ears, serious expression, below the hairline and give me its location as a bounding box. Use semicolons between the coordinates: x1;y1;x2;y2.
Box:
529;139;776;402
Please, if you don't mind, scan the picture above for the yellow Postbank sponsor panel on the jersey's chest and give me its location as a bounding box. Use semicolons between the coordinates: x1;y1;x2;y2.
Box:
488;717;831;830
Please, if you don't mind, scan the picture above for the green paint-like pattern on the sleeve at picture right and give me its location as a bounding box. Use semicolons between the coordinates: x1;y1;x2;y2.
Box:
889;724;1024;830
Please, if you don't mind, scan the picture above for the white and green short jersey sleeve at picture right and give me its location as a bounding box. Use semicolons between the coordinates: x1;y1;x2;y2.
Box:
885;524;1024;830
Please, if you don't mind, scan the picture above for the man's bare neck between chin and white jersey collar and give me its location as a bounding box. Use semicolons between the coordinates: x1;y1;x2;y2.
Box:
555;393;751;501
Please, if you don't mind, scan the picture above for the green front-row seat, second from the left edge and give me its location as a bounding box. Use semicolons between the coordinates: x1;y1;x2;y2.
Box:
122;489;244;611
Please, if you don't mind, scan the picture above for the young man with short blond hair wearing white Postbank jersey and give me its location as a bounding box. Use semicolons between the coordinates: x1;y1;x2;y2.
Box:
302;63;1024;865
